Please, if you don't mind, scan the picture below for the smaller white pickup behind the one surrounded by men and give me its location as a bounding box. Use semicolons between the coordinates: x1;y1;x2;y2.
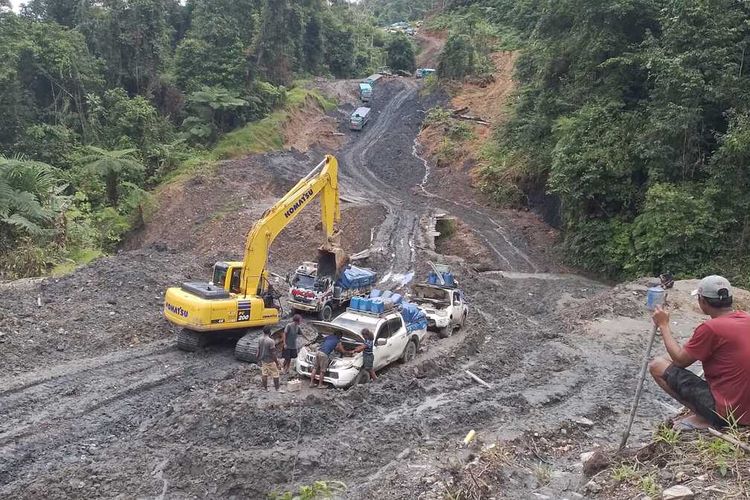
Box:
409;283;469;338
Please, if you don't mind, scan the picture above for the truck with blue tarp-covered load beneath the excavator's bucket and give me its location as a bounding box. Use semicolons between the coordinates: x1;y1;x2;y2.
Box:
289;250;377;321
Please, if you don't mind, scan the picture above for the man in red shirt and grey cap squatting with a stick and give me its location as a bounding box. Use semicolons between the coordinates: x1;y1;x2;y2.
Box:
649;276;750;430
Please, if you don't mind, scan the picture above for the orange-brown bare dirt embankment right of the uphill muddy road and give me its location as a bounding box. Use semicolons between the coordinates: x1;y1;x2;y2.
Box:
415;51;565;270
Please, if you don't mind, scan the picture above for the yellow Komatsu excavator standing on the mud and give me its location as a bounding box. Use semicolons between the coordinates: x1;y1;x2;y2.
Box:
164;155;341;362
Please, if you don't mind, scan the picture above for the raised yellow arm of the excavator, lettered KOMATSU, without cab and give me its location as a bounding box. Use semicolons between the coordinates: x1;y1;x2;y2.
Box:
240;155;341;296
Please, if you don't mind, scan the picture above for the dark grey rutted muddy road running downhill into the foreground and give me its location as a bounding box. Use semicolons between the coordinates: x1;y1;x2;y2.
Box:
0;79;680;499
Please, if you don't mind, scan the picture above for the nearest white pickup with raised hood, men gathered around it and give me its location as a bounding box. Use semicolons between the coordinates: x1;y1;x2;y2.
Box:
297;308;427;387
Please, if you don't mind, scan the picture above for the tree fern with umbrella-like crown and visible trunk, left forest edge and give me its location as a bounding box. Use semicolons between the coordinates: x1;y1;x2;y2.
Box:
81;146;145;207
